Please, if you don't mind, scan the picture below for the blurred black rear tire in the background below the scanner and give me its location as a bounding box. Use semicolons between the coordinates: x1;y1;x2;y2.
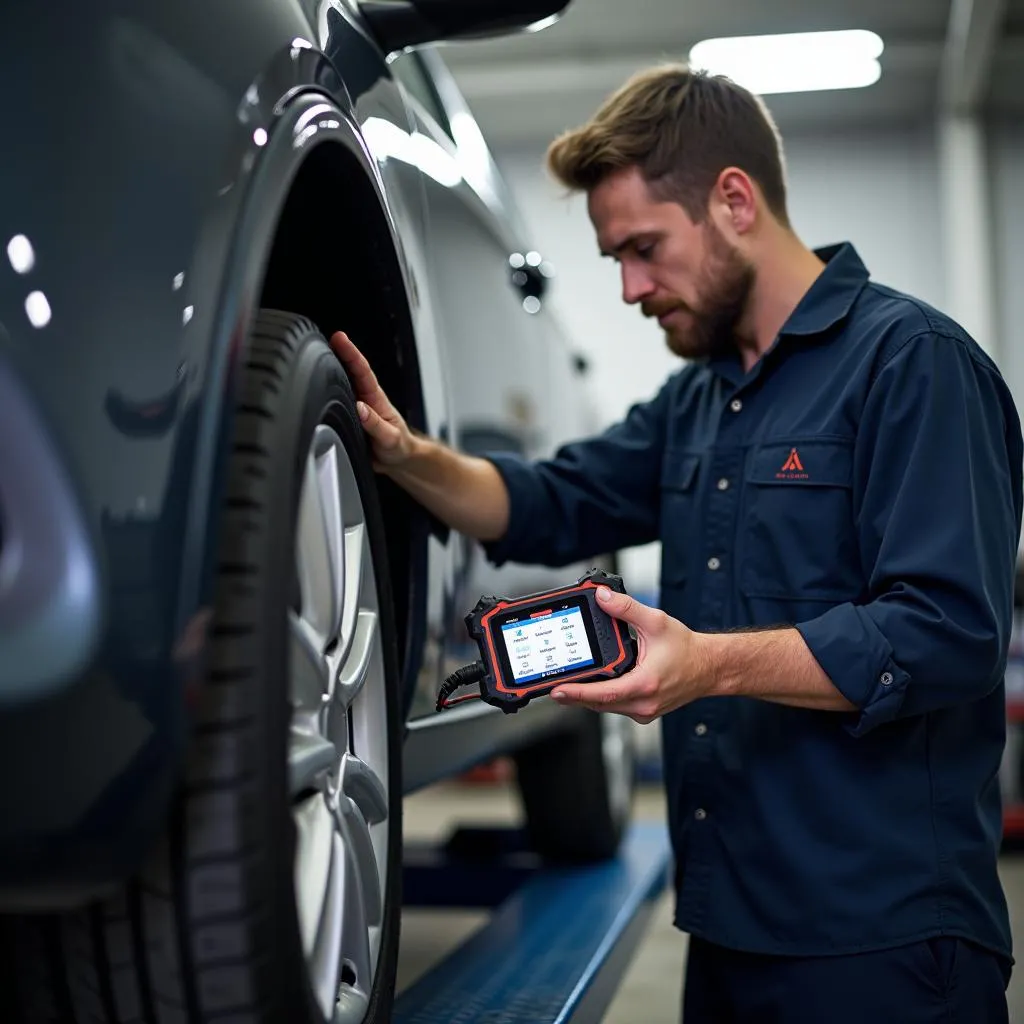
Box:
514;712;636;864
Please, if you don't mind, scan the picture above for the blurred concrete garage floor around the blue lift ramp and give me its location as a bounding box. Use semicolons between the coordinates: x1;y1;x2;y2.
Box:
398;782;1024;1024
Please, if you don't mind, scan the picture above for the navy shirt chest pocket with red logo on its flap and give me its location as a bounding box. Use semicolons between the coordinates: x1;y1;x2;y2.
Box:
739;438;864;602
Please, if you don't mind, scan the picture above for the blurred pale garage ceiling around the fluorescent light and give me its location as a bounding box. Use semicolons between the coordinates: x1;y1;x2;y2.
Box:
443;0;1024;147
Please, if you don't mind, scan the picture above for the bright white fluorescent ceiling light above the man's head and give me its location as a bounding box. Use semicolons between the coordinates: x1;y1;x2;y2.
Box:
689;29;884;95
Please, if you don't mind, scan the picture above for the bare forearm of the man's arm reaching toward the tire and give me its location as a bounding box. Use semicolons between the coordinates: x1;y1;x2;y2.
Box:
381;437;509;541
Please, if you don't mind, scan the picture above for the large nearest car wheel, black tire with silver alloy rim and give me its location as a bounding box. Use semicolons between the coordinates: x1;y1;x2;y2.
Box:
4;311;401;1024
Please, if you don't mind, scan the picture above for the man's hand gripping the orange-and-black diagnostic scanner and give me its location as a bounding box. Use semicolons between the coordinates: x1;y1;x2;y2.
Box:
551;587;714;725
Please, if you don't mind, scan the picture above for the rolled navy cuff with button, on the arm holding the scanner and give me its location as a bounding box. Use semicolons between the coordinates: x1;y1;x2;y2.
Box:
796;604;910;736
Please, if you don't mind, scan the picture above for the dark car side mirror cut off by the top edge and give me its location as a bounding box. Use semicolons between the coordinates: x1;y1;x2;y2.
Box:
359;0;570;53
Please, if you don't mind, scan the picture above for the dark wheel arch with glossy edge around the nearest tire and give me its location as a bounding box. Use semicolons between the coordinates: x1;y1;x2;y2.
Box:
185;91;430;720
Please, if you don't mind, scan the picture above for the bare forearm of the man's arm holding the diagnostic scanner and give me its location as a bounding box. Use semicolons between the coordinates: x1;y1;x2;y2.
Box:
698;629;857;712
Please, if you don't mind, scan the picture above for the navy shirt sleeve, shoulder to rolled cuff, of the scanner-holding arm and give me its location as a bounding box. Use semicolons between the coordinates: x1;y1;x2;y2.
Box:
797;332;1024;735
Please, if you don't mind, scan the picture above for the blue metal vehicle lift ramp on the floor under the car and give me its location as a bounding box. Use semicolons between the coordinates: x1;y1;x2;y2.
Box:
392;823;672;1024
